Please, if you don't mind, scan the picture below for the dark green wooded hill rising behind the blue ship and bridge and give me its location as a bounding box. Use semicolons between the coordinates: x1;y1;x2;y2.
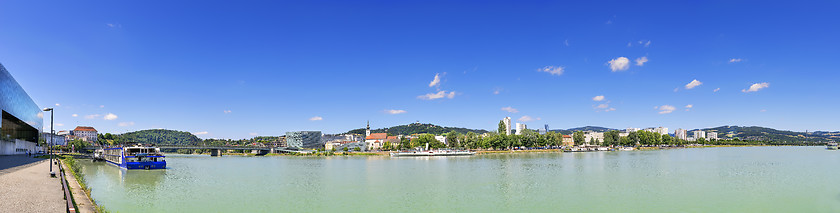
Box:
114;129;202;145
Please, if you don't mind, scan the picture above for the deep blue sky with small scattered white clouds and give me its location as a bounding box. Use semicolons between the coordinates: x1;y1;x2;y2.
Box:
0;0;840;139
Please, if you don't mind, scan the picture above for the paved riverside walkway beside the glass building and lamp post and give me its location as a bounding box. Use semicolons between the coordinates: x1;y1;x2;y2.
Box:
0;155;67;212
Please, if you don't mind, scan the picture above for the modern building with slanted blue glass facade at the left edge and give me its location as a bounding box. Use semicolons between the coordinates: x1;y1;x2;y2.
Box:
0;64;44;154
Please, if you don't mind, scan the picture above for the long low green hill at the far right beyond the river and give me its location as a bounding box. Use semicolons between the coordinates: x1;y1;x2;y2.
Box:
702;126;840;142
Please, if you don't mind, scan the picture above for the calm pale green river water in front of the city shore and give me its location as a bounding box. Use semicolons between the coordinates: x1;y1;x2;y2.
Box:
81;147;840;212
